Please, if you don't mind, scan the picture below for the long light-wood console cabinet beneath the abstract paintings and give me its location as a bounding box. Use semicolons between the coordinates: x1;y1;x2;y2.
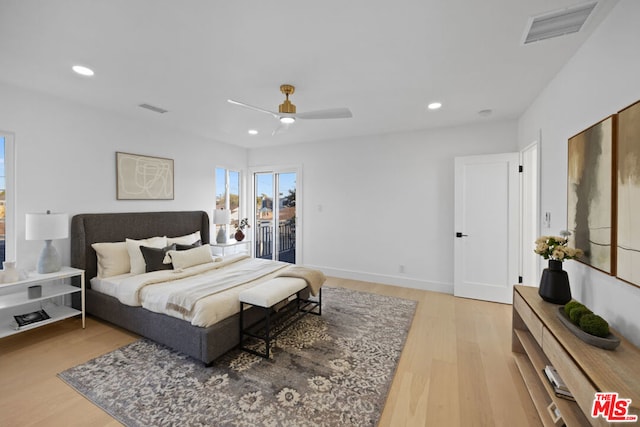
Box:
512;285;640;427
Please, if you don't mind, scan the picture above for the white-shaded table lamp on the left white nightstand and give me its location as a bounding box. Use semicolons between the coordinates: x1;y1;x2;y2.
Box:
25;211;69;274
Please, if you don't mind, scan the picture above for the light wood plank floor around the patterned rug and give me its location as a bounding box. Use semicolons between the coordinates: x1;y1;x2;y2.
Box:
0;278;540;427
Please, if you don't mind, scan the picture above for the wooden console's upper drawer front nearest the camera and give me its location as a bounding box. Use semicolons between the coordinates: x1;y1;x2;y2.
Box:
542;328;607;425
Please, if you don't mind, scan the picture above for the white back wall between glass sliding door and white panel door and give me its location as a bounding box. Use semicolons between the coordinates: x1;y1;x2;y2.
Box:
249;121;517;293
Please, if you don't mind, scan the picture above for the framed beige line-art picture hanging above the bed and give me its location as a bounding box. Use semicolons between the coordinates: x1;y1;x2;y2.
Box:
116;152;174;200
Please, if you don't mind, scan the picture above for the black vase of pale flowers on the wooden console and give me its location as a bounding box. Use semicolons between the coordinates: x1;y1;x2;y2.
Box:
534;231;583;304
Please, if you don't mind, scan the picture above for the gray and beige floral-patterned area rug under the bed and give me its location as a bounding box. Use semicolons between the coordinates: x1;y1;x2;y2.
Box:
58;287;416;427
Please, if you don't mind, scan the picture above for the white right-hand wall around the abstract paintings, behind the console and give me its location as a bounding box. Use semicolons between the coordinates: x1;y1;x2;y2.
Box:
518;0;640;345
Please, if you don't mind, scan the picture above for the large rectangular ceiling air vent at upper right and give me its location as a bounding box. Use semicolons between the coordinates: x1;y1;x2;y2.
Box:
524;1;598;44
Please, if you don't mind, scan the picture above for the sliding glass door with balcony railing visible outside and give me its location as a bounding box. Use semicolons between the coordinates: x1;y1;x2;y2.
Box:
254;171;297;264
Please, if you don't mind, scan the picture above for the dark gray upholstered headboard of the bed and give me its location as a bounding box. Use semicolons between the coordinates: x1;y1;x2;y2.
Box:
71;211;209;286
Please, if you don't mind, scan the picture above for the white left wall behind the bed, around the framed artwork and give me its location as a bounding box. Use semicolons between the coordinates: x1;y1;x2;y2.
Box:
0;84;246;270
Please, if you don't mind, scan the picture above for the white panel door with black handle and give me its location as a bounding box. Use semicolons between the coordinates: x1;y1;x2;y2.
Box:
453;153;520;303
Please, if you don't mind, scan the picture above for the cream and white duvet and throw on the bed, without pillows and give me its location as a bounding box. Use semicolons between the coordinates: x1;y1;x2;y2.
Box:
91;255;306;327
